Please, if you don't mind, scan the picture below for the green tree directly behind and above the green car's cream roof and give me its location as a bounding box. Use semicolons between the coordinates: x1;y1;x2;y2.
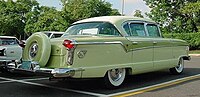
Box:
61;0;120;23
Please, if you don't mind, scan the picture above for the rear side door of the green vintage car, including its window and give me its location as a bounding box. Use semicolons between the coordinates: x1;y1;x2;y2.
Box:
124;21;153;73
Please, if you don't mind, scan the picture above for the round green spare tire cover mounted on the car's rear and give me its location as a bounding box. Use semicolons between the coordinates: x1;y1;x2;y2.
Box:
22;32;51;67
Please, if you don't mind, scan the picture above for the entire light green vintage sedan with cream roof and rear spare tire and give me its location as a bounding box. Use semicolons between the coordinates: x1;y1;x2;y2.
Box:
15;16;190;87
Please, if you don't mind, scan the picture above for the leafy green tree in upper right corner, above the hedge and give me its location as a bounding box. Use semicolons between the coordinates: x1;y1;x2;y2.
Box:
144;0;200;33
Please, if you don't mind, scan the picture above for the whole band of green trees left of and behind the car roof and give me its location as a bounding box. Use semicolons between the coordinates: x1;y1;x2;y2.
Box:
0;0;120;39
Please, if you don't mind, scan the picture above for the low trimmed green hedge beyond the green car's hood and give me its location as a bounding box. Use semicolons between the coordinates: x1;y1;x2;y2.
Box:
163;32;200;50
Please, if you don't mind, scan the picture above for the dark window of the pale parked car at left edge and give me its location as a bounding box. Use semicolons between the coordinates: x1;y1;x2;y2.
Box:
0;38;18;45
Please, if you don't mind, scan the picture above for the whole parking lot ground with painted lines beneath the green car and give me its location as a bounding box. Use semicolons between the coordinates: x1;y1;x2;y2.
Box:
0;57;200;97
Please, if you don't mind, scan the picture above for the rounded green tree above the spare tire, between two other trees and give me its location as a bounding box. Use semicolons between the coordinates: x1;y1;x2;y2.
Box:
25;6;69;34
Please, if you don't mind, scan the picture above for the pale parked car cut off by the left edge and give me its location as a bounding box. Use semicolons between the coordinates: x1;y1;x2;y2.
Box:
0;36;23;68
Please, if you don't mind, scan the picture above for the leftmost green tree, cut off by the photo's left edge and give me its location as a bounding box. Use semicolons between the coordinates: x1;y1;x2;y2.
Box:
0;0;39;38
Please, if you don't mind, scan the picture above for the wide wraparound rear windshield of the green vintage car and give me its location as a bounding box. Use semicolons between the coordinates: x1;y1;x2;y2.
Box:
62;22;121;37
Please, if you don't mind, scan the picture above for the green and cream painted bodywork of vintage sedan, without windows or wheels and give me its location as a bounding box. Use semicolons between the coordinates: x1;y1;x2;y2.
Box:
44;17;188;78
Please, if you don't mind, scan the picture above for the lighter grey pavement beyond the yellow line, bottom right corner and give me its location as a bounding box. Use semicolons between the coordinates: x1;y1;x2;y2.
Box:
132;79;200;97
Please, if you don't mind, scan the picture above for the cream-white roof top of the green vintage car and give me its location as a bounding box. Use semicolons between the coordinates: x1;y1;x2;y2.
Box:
73;16;155;24
